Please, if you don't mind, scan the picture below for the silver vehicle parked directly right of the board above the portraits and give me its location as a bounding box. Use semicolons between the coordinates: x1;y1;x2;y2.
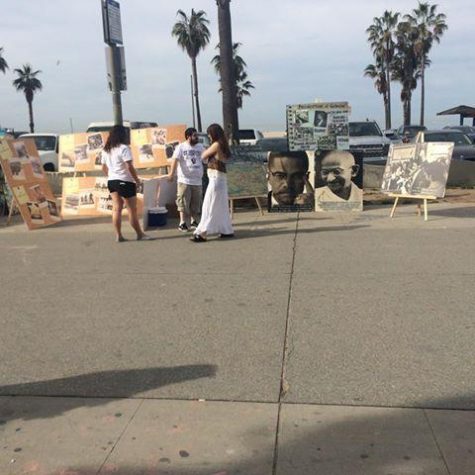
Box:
348;120;391;161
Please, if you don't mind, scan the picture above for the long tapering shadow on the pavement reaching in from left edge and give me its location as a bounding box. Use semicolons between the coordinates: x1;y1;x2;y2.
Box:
0;364;217;426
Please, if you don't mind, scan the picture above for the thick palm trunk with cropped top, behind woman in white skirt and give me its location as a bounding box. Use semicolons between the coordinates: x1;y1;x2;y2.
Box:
216;0;239;142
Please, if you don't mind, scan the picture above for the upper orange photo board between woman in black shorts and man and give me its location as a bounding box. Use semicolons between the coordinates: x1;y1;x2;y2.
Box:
130;124;186;168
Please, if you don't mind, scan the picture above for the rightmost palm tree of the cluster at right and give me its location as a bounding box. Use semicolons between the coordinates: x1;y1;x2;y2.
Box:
404;2;448;125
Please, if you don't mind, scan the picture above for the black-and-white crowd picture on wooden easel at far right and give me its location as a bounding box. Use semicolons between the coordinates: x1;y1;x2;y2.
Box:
381;142;454;198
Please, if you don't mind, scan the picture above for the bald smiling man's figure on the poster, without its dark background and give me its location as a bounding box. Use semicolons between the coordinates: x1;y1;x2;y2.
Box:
315;151;363;211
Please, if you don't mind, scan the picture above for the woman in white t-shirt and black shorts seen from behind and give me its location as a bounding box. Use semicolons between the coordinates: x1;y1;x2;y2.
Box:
101;125;152;242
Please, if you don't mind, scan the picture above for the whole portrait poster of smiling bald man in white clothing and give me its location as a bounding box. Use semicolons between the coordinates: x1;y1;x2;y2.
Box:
313;150;363;212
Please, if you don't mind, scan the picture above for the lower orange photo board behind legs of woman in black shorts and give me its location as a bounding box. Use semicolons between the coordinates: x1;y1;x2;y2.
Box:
61;177;143;217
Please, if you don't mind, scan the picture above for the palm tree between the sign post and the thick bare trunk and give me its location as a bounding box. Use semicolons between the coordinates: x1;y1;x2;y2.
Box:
172;9;211;132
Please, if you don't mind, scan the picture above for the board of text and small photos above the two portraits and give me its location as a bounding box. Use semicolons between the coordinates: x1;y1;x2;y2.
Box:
287;102;350;151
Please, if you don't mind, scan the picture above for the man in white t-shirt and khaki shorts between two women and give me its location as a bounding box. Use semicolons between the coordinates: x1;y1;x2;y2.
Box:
168;127;204;232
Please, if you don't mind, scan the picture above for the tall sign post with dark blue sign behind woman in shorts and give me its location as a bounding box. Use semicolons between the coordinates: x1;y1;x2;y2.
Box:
101;0;127;125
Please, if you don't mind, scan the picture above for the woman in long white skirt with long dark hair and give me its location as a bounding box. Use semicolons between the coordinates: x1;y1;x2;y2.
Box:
191;124;234;242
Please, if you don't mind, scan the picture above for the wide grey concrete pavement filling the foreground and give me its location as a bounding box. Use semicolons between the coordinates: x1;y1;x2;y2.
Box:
0;203;475;475
